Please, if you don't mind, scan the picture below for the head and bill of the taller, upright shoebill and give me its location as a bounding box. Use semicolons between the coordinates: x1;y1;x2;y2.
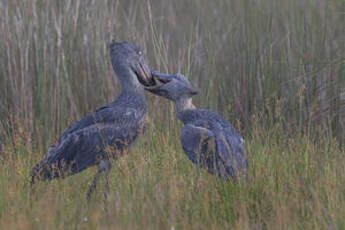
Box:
109;41;153;86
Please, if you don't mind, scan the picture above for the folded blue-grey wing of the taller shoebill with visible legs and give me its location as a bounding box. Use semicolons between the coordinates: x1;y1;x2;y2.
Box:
32;107;141;180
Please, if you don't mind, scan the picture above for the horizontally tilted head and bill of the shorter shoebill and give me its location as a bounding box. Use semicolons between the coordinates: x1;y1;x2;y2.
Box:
145;71;197;101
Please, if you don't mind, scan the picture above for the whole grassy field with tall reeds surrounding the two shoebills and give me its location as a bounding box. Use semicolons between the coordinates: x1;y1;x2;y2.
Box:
0;0;345;229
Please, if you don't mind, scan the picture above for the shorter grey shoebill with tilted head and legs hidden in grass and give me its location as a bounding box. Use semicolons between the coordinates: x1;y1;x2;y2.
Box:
145;71;247;180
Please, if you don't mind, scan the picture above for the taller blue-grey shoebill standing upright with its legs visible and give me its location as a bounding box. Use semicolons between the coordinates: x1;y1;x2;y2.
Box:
31;42;152;199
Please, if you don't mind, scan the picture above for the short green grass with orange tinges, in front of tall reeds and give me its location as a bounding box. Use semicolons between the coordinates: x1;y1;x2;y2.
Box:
0;123;345;229
